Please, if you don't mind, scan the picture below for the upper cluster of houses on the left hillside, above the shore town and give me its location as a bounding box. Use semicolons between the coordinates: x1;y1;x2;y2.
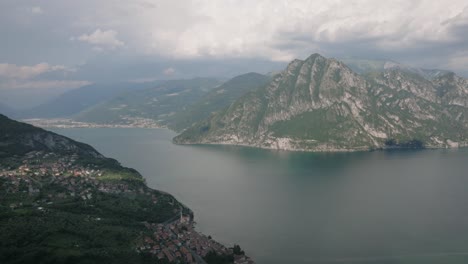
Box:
0;152;143;208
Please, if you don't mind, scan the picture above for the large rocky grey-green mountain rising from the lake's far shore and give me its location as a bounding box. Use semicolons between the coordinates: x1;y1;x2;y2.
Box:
174;54;468;151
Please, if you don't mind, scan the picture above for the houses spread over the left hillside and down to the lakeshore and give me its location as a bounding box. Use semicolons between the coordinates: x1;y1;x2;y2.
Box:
0;151;254;264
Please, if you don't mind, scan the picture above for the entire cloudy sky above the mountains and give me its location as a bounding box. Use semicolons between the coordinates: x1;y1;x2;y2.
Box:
0;0;468;108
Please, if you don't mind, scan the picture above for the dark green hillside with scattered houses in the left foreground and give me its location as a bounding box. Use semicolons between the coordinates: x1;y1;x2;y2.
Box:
0;115;183;263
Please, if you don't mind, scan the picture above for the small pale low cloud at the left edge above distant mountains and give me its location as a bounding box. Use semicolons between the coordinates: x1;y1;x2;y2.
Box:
0;63;68;79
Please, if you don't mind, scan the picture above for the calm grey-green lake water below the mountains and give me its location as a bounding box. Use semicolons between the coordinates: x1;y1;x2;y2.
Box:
55;129;468;264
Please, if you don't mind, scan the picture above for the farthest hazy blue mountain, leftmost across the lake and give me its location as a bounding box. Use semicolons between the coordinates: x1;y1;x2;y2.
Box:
18;82;161;118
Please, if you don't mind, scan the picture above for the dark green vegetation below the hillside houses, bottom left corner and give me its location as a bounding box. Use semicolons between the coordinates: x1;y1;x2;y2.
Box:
0;190;177;263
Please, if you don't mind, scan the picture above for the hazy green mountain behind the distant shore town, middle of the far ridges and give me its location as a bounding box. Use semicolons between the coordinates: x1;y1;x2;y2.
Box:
73;78;220;124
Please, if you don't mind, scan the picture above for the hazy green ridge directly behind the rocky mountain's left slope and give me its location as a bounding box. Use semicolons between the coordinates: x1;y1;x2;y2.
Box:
165;72;270;131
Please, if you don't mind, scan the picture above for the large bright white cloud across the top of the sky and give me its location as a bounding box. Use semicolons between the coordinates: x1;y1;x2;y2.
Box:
71;0;462;61
